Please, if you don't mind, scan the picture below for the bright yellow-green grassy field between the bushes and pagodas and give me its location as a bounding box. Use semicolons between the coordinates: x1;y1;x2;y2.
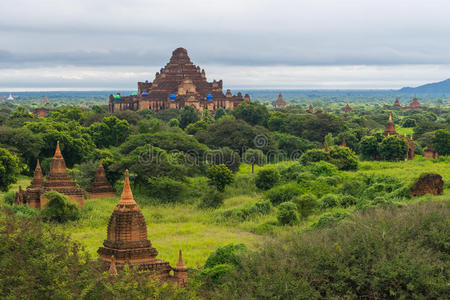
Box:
0;156;450;268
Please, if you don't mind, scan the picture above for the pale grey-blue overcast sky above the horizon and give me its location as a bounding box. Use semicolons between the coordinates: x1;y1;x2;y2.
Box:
0;0;450;90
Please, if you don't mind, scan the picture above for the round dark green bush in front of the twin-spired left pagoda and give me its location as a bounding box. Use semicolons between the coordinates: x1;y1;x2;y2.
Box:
42;191;80;223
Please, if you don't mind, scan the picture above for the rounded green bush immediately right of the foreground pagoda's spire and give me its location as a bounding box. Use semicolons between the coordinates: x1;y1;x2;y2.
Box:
144;177;187;203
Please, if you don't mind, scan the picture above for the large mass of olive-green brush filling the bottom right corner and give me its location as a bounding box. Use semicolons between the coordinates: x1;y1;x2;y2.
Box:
206;201;450;299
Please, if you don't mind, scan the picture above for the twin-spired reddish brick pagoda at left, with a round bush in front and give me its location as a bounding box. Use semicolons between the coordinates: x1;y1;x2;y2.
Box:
14;141;84;209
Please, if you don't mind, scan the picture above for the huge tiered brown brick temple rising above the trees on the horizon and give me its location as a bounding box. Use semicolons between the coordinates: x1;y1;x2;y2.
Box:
109;48;250;113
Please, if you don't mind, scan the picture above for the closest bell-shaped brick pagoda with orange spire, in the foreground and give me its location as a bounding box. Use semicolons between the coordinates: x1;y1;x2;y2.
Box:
97;170;188;285
